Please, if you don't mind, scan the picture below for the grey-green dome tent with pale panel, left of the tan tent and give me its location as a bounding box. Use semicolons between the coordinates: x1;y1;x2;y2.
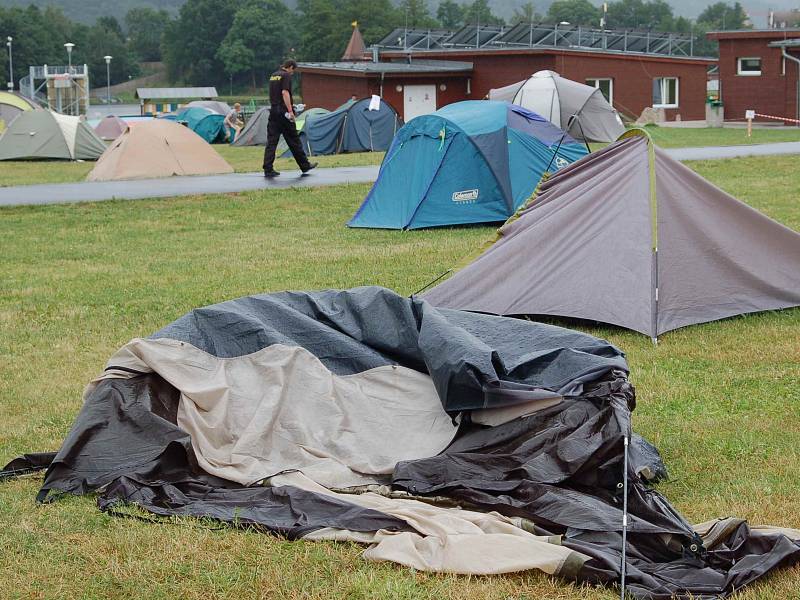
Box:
0;108;106;160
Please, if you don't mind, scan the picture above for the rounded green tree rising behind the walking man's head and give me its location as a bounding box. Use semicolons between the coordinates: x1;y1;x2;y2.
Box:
217;0;297;87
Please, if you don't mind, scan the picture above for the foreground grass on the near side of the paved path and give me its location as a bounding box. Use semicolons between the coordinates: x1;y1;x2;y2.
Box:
0;156;800;600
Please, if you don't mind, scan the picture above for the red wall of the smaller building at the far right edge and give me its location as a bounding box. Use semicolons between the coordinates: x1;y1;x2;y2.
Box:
719;36;798;123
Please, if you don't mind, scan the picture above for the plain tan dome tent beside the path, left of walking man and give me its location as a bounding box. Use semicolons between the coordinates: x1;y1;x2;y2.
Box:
86;119;233;181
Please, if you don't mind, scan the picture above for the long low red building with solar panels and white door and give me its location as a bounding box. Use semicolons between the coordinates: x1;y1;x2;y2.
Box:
300;23;716;120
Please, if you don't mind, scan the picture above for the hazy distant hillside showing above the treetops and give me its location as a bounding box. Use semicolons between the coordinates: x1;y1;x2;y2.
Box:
0;0;800;27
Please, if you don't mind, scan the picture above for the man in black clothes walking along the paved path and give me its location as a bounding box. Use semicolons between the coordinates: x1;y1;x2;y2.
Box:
264;59;318;177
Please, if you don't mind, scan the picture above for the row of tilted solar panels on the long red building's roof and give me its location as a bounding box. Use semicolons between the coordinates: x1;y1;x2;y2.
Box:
374;23;708;57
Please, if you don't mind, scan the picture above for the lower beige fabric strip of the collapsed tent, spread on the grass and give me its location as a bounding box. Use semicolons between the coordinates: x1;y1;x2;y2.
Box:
269;473;589;576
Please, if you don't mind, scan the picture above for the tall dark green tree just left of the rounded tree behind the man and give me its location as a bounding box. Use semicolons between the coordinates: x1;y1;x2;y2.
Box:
162;0;241;85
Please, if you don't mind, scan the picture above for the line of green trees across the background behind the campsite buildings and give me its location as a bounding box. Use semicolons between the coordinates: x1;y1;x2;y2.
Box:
0;0;750;92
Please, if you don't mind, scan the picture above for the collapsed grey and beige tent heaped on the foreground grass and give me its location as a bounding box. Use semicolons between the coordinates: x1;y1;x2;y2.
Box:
0;288;800;599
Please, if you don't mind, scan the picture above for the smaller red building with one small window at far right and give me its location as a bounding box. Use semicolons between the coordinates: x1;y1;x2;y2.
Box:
708;29;800;122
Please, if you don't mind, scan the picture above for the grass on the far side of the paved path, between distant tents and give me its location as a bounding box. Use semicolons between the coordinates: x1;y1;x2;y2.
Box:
0;127;800;186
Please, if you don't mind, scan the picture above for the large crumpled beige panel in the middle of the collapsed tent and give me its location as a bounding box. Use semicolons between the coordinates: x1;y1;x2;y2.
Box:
95;338;457;488
